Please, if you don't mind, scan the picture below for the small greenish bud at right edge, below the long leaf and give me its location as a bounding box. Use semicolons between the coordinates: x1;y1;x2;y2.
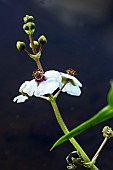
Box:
102;126;113;139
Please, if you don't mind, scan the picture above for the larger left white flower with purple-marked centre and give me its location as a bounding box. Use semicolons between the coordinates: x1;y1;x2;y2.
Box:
13;70;61;103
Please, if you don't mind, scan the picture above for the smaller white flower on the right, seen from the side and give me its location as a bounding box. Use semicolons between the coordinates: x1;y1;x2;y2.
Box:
60;73;82;96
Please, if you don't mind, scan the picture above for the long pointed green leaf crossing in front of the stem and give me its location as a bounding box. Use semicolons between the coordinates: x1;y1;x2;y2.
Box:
51;105;113;150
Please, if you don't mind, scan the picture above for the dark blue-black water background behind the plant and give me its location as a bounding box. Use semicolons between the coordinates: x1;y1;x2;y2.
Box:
0;0;113;170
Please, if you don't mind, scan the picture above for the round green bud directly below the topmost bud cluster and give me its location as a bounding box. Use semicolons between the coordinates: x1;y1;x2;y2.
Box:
23;22;35;35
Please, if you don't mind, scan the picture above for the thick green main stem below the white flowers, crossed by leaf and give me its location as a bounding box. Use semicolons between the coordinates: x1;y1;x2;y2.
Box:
50;97;99;170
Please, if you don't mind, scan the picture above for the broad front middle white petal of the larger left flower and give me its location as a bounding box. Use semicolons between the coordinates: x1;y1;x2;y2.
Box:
34;78;59;97
